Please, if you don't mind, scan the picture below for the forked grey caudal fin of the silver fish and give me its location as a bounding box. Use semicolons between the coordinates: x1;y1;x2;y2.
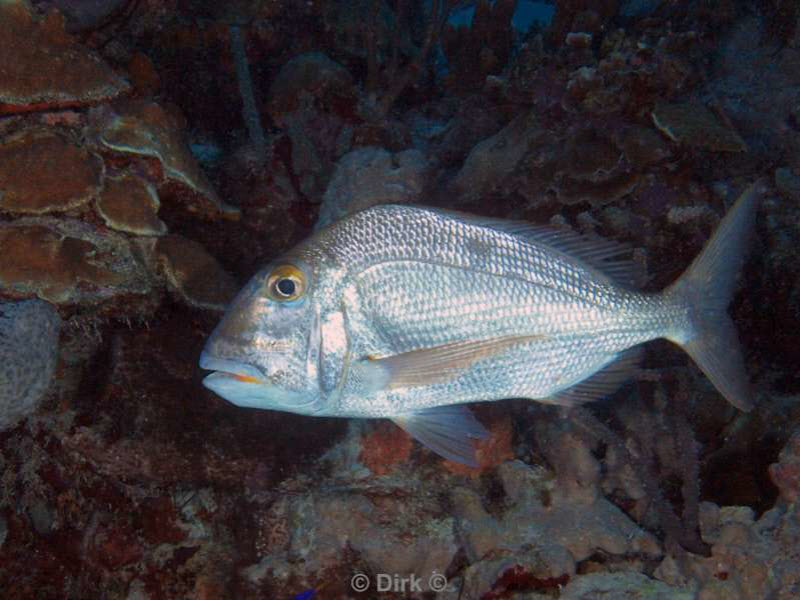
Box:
668;183;759;410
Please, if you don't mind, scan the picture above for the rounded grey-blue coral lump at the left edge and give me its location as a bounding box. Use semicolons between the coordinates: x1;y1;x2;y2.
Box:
0;300;61;431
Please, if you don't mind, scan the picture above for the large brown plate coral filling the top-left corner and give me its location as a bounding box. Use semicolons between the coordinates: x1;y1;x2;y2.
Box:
0;0;130;114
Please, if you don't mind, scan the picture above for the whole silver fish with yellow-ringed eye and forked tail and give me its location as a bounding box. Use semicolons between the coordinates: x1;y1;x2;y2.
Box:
199;184;759;466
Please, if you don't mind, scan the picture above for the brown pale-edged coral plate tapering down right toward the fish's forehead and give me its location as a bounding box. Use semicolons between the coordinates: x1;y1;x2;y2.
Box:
90;100;239;219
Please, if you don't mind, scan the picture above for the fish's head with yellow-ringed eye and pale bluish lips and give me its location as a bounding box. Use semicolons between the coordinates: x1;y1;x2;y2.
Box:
200;261;321;414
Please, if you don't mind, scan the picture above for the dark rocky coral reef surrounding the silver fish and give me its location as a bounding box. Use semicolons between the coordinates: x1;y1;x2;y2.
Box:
0;0;800;600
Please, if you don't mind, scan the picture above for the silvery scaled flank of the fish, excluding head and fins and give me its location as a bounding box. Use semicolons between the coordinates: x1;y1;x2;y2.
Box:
300;206;685;416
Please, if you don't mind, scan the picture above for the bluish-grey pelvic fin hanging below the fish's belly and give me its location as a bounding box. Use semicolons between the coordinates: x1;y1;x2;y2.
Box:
392;405;489;467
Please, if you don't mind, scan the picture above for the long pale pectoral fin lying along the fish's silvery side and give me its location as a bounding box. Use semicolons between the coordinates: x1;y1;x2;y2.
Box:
353;335;544;392
